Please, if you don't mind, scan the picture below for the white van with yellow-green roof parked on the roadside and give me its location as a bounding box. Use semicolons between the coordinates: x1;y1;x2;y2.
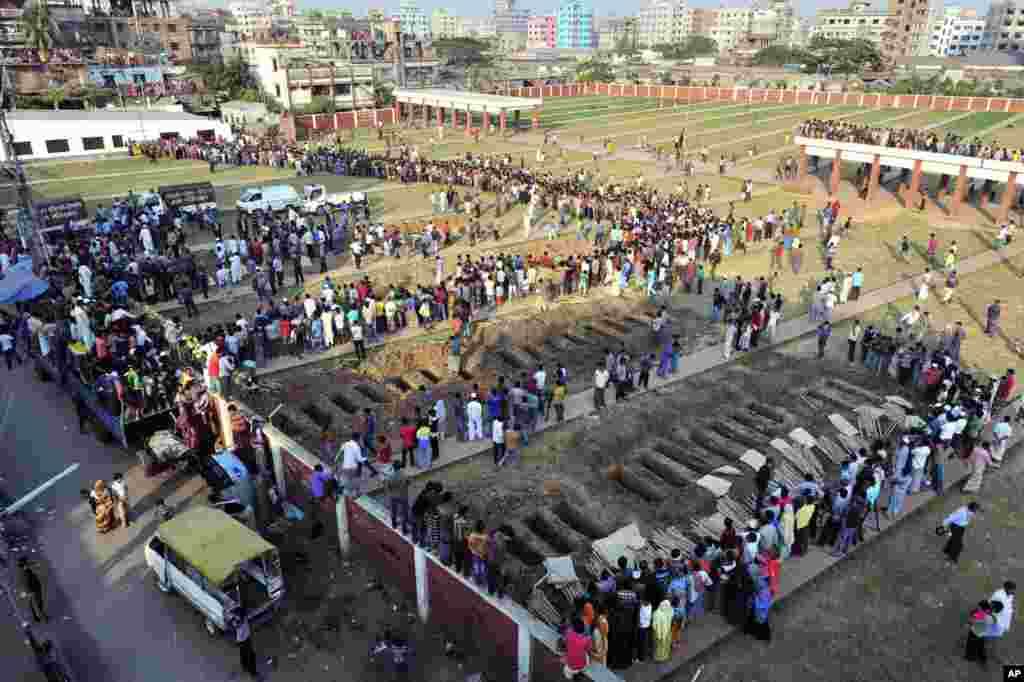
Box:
145;506;285;635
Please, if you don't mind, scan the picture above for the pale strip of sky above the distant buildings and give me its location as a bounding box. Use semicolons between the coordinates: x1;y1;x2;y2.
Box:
297;0;988;16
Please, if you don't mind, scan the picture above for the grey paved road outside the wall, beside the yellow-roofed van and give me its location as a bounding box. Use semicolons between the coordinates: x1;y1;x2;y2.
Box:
0;367;240;682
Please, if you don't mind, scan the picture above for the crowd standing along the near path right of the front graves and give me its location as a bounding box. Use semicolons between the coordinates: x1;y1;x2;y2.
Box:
544;342;1020;678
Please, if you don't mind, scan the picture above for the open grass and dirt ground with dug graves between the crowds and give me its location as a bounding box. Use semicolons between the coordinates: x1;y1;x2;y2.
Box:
9;91;1024;680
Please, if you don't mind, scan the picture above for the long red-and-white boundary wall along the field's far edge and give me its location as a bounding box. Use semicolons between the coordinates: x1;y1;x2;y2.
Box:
499;83;1024;114
